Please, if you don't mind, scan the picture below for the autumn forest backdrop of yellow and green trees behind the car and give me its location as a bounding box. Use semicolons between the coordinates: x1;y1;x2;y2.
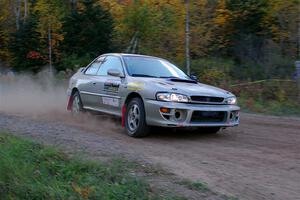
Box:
0;0;299;85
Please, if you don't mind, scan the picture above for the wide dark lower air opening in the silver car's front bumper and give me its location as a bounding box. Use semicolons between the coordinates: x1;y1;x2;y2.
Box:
191;111;227;123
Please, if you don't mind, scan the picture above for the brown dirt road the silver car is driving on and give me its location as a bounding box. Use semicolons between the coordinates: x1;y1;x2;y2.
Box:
0;113;300;200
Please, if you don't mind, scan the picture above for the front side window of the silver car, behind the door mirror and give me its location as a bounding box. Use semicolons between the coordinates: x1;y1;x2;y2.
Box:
97;56;123;76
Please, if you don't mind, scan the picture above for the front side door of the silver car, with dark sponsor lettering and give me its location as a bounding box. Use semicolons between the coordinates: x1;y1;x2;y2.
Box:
97;56;124;114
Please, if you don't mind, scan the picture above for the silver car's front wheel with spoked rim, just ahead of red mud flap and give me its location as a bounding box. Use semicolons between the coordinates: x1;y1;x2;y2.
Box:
125;98;149;138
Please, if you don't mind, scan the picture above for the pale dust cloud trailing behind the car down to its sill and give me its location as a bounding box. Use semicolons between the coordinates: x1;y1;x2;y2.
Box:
0;71;120;133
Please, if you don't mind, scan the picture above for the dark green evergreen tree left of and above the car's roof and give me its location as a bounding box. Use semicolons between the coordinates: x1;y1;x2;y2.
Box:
62;0;113;69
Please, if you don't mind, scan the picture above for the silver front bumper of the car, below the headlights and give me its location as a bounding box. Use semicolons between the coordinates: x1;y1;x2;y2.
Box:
144;99;240;127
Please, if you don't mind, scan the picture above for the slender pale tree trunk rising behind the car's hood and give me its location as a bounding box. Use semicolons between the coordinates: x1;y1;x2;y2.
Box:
185;0;191;75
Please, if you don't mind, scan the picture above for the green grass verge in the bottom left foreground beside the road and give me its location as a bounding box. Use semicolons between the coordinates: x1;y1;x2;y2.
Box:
0;133;183;200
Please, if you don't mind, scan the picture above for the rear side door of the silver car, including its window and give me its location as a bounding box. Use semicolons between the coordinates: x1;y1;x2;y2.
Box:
79;56;105;108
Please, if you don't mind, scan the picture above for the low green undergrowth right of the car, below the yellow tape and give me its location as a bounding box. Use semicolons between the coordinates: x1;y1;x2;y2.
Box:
231;80;300;115
